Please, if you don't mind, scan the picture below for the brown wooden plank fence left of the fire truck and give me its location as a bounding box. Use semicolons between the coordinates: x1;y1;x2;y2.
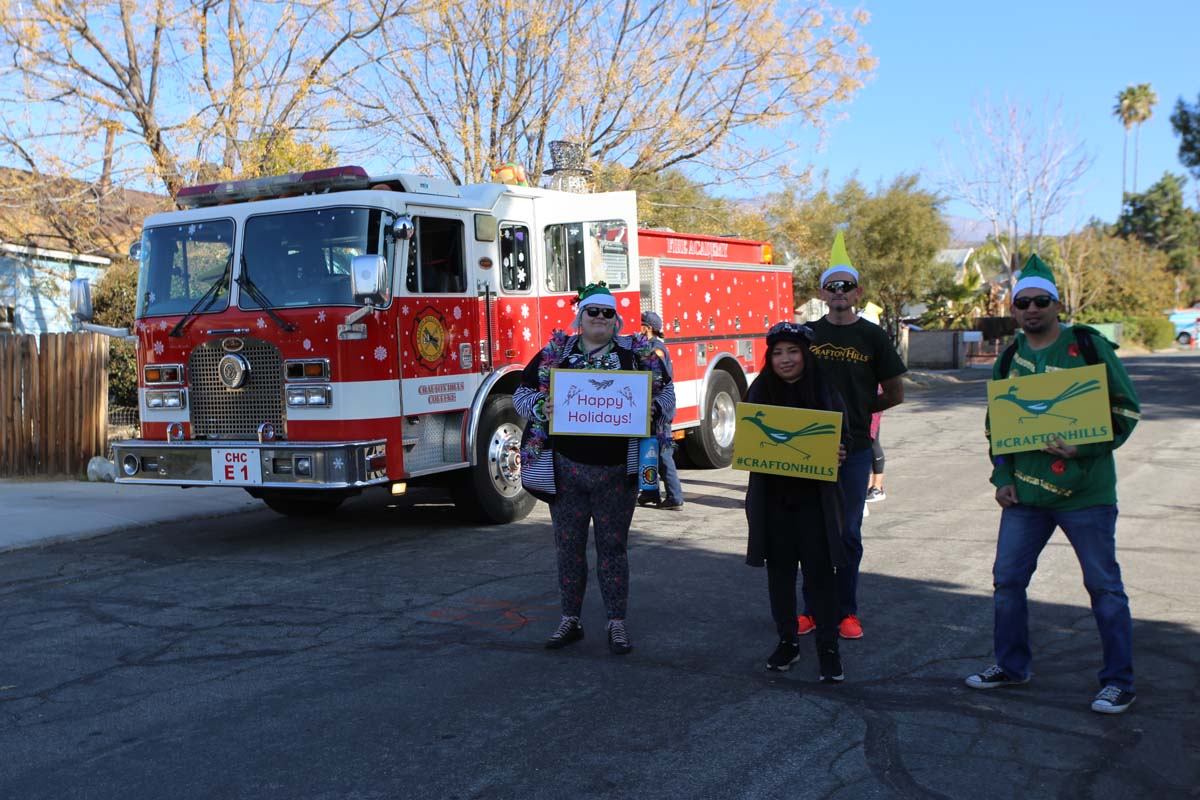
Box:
0;333;108;477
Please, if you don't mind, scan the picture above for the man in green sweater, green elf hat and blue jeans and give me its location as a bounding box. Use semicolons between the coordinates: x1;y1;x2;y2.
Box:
966;255;1140;714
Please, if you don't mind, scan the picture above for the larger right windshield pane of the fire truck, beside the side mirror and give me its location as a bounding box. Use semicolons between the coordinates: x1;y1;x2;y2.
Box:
238;207;384;309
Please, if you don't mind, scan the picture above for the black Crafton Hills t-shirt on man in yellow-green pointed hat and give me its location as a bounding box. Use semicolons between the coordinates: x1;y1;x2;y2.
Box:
809;317;908;450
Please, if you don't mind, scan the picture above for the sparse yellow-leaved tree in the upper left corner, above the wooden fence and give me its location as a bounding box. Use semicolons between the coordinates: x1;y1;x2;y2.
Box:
0;0;408;196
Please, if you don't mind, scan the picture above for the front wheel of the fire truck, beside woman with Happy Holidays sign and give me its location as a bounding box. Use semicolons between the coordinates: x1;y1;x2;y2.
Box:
450;395;536;524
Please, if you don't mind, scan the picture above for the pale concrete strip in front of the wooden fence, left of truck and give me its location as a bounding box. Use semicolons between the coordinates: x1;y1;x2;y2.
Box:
0;479;265;553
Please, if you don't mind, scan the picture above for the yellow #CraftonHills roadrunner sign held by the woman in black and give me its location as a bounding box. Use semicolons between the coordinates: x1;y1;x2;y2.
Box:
733;403;841;481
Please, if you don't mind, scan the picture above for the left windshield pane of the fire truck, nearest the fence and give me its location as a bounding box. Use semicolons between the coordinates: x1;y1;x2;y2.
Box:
137;219;234;318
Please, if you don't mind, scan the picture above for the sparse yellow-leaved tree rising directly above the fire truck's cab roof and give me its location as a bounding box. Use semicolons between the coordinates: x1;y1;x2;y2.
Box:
342;0;875;182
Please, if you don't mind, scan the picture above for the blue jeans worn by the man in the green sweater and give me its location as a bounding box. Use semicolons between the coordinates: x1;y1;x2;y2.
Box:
992;505;1134;692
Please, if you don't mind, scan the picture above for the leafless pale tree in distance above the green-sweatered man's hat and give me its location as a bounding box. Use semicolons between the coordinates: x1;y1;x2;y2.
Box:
942;98;1094;282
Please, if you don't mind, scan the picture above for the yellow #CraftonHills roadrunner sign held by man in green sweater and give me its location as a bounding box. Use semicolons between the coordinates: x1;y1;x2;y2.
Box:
988;363;1112;453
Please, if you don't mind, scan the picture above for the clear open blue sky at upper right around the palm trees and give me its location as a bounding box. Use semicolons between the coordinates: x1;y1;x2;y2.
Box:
800;0;1200;233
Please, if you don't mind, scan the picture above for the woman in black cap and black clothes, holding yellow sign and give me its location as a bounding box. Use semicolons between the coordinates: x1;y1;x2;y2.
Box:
746;323;847;682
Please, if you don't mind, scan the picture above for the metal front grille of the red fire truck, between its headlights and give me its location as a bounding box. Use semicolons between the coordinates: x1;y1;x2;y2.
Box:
187;338;284;439
